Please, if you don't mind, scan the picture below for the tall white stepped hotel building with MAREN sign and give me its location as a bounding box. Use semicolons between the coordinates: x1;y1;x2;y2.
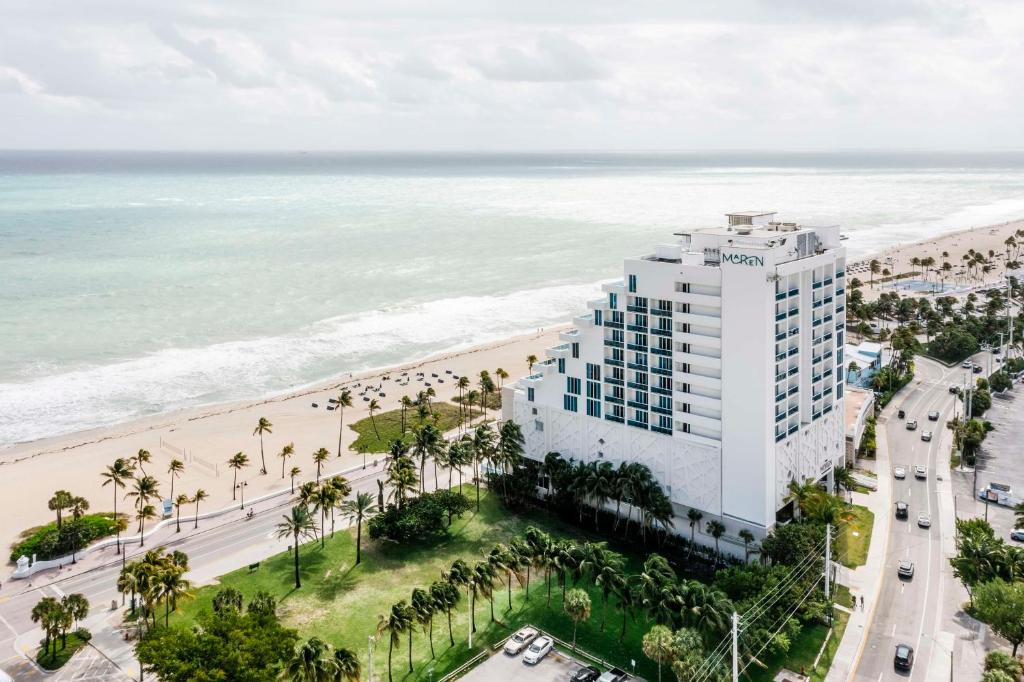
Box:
503;211;846;542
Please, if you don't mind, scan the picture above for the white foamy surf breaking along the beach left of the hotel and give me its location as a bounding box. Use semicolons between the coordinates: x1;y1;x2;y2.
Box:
0;284;600;445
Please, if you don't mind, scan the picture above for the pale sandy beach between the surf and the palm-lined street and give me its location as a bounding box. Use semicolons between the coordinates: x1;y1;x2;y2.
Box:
0;220;1024;574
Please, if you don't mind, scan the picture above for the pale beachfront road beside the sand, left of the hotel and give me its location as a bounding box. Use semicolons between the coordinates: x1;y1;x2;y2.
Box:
0;454;403;680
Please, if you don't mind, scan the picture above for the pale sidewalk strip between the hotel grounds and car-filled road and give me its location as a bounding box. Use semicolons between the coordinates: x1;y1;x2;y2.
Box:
825;417;893;682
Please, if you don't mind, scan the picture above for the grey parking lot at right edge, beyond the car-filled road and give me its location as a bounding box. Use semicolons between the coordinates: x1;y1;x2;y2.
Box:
952;376;1024;542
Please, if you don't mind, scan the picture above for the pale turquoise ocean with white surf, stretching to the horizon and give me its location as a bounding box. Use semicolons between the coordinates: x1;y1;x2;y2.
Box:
0;152;1024;446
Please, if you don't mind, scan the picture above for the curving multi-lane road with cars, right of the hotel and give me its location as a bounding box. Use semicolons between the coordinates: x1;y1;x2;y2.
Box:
855;355;985;682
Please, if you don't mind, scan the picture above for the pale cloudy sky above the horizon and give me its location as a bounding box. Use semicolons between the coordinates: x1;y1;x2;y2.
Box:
0;0;1024;150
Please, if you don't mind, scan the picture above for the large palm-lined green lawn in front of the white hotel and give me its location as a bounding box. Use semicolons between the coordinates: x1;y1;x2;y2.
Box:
176;485;656;680
